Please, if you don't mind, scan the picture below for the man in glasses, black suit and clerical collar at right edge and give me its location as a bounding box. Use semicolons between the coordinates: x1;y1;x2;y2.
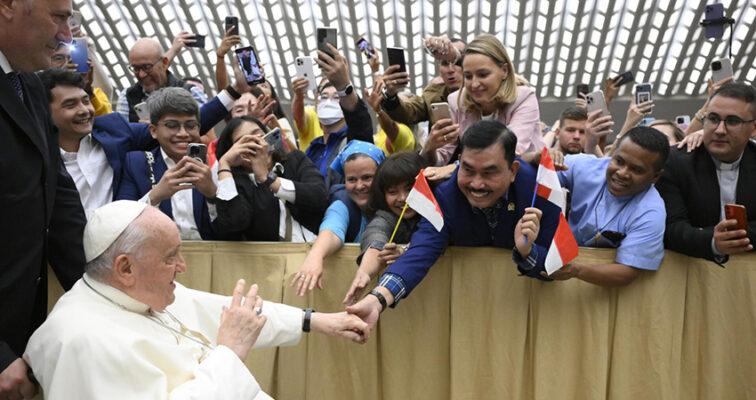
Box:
656;83;756;264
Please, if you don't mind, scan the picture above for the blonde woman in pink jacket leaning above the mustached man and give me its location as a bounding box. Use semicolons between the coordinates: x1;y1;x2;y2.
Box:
423;34;544;166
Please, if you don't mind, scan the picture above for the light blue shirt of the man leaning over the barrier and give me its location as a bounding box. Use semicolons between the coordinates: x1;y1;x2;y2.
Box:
558;154;667;270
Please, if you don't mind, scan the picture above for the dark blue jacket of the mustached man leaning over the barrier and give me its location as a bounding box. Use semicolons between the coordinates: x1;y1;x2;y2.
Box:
386;160;560;294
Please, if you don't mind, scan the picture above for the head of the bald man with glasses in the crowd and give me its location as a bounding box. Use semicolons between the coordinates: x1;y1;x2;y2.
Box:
129;38;168;92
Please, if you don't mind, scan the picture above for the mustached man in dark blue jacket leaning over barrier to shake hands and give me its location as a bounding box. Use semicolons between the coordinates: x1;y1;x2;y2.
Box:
347;120;560;327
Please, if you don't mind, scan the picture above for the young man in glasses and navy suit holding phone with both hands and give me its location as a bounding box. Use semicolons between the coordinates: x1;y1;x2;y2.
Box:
116;87;217;240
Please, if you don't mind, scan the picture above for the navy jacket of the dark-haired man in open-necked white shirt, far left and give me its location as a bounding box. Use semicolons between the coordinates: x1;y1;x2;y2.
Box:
92;97;228;199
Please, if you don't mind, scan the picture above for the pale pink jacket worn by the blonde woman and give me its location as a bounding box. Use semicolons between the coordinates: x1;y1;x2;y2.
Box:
436;86;544;166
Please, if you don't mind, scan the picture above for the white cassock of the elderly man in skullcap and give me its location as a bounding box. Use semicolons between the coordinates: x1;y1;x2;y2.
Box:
24;274;302;400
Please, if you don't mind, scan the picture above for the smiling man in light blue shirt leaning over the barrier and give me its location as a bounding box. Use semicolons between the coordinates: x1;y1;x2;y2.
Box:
543;127;669;286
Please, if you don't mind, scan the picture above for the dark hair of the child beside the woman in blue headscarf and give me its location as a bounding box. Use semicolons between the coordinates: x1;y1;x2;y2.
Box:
368;151;426;214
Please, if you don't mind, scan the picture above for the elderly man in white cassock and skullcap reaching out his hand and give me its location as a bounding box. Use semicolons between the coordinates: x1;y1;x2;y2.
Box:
24;201;368;400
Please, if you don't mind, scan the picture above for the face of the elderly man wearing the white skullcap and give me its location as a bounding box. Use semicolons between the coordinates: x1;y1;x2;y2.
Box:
130;207;186;311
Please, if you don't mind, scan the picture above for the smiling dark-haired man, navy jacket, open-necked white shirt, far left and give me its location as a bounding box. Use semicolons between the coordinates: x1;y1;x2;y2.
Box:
39;69;247;218
